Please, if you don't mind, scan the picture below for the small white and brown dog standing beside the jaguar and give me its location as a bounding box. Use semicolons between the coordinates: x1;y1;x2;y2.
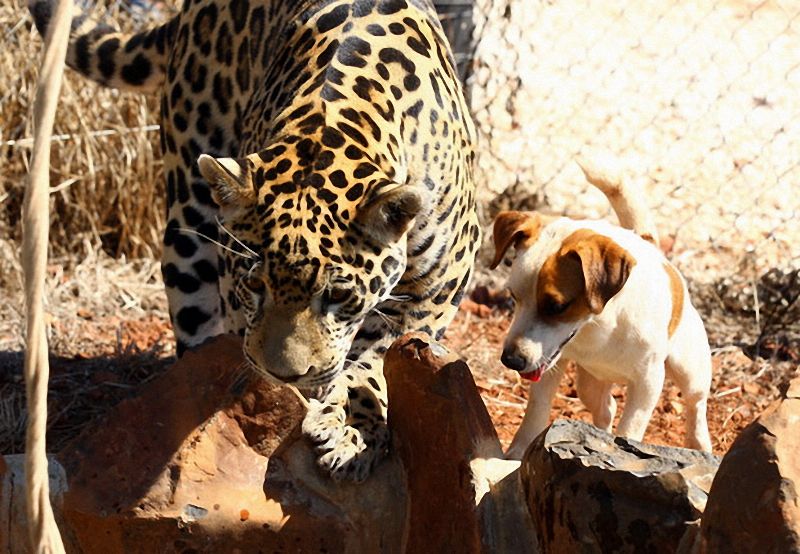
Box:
492;163;711;458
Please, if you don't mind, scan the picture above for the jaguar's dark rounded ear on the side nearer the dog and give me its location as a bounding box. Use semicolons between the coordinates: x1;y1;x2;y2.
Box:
358;185;423;244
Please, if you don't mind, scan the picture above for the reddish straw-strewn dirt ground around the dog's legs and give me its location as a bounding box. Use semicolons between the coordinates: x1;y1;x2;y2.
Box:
444;299;795;454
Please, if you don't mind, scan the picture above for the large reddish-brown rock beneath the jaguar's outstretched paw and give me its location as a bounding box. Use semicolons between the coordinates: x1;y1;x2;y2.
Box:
59;336;405;553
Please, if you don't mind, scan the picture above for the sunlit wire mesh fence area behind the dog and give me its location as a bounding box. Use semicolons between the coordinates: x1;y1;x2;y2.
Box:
471;0;800;280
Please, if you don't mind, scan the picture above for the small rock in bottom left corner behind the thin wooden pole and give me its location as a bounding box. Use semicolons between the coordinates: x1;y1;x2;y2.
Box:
0;454;72;554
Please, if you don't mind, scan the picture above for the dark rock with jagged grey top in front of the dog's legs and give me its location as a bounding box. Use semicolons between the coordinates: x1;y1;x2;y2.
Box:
521;420;719;553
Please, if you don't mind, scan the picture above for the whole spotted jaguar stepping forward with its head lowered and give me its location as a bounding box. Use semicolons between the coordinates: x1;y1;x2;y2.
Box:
31;0;480;479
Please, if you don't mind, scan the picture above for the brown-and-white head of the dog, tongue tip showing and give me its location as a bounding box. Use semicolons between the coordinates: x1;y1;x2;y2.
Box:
492;212;636;381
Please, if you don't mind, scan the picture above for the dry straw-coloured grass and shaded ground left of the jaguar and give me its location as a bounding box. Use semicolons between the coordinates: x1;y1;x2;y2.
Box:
0;0;178;454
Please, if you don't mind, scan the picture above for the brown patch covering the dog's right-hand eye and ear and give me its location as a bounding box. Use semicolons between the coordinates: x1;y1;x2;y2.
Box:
536;229;636;322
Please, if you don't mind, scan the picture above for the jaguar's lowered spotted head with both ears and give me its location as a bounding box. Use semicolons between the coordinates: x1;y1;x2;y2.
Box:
198;151;423;387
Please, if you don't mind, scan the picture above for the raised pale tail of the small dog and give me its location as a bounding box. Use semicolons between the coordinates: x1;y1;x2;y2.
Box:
578;156;658;245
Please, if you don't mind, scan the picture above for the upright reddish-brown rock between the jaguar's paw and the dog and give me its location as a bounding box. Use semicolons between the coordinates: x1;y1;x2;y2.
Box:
384;333;535;552
